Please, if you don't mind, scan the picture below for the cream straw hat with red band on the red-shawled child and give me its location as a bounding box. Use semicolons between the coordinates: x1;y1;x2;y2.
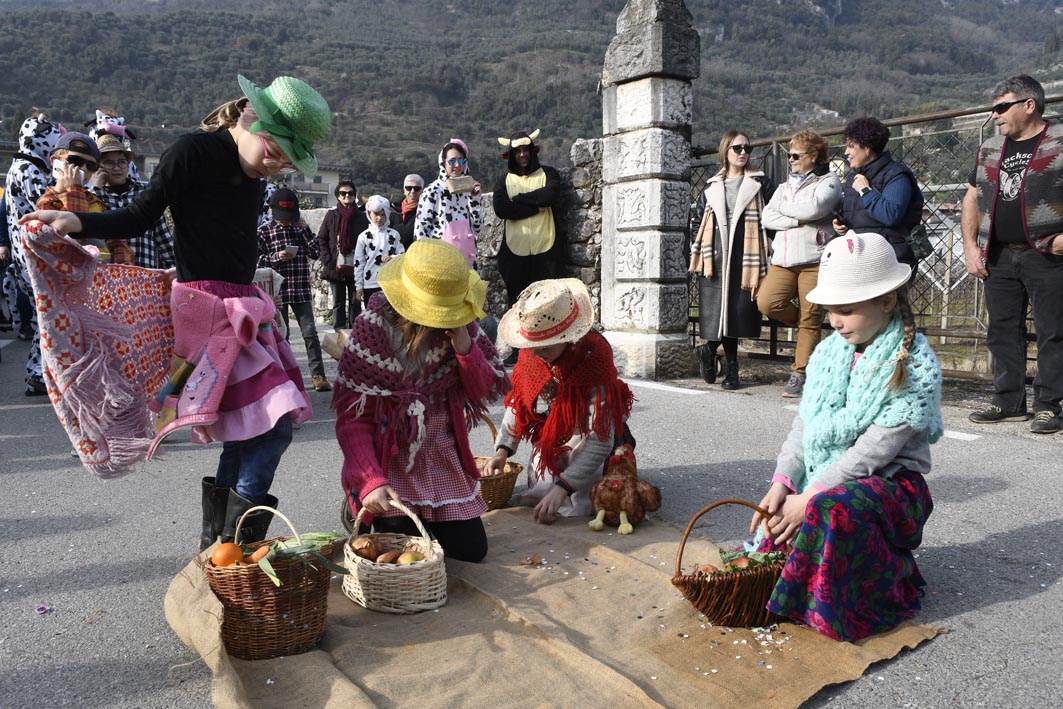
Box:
499;278;594;349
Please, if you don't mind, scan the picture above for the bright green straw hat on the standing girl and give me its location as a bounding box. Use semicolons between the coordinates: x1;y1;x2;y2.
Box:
237;75;332;178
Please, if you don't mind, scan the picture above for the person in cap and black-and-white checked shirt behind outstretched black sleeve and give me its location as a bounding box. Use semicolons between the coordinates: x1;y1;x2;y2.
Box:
89;133;173;269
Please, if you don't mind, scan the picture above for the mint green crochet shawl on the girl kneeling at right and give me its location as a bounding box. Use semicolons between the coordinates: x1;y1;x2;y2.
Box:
797;315;944;492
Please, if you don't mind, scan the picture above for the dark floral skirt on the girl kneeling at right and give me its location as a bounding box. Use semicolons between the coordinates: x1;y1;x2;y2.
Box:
760;471;933;642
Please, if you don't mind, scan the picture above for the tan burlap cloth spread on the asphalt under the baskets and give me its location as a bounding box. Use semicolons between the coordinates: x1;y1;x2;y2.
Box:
166;509;941;708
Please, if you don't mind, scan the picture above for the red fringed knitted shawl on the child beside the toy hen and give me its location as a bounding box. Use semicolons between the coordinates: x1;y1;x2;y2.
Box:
506;332;635;478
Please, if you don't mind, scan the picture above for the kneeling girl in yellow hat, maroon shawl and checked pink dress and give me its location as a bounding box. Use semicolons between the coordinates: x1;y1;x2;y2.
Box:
333;239;509;561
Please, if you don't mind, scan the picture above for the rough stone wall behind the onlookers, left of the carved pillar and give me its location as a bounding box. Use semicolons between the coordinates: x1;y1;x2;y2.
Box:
302;139;602;329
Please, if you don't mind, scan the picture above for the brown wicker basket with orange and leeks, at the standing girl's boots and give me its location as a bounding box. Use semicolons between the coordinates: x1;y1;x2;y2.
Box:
203;506;333;660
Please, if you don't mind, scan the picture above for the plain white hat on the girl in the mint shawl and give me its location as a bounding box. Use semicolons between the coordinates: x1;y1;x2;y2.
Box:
806;232;912;305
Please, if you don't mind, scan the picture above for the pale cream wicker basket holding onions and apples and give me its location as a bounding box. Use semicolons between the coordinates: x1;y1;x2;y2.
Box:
343;500;446;613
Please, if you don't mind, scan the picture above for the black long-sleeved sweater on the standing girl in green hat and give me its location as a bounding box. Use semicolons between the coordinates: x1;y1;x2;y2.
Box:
72;130;266;284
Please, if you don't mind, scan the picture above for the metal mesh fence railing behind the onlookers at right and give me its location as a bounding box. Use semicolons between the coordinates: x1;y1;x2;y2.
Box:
688;96;1063;378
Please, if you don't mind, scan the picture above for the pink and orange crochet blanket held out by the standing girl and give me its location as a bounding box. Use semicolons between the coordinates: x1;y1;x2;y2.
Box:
22;222;173;477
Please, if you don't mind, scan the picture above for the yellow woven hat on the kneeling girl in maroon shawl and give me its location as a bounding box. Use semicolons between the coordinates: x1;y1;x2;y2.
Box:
376;239;487;330
